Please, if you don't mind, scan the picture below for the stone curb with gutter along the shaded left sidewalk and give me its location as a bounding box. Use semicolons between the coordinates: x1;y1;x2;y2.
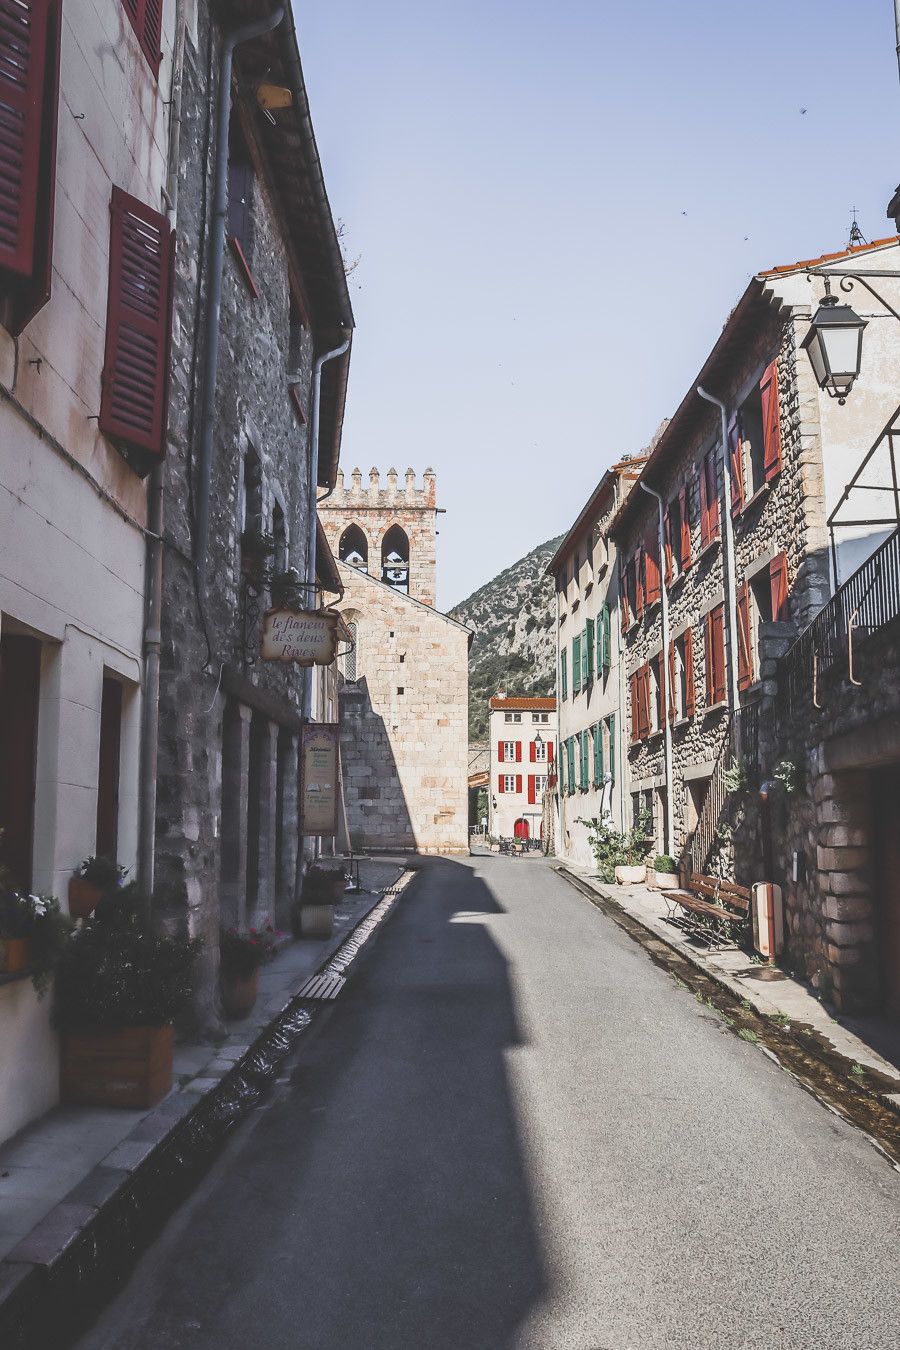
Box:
0;869;421;1350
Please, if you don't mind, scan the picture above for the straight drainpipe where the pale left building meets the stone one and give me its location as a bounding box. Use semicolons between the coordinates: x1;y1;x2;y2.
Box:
138;0;186;896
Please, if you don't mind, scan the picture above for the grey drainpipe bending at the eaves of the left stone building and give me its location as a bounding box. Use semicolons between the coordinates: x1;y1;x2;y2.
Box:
194;5;285;595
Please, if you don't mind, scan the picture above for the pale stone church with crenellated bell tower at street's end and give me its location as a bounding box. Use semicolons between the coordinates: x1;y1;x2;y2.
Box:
320;468;471;853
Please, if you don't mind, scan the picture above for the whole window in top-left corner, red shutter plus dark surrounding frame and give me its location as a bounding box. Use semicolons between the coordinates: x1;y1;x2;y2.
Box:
0;0;62;336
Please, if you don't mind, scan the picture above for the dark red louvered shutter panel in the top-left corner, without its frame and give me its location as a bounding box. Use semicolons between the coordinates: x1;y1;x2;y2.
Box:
0;0;50;277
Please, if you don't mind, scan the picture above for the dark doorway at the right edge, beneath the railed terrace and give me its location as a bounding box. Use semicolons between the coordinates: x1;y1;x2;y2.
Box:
872;764;900;1021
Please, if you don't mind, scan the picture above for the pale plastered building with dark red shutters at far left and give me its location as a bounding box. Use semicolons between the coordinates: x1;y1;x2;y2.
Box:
0;0;177;1139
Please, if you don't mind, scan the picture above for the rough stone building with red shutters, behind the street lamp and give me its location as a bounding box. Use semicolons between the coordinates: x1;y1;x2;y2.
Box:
611;239;900;1000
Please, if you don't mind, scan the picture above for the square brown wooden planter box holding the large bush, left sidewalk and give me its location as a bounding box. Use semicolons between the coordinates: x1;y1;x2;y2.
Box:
59;1026;174;1107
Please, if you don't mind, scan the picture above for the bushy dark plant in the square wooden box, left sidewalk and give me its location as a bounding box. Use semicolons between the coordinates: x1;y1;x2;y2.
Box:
53;887;200;1107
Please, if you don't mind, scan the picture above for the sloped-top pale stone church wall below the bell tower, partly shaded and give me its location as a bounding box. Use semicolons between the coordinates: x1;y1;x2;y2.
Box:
339;564;470;853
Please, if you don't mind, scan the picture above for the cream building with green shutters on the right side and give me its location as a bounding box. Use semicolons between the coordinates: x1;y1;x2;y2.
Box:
546;455;646;867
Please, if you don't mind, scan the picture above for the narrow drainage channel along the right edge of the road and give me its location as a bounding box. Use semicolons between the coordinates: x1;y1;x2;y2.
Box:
553;867;900;1172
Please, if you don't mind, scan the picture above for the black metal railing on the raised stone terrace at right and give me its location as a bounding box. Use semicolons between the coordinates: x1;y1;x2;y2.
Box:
779;529;900;721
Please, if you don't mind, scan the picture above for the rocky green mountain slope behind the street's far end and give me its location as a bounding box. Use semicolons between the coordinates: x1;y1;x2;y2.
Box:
449;535;563;741
